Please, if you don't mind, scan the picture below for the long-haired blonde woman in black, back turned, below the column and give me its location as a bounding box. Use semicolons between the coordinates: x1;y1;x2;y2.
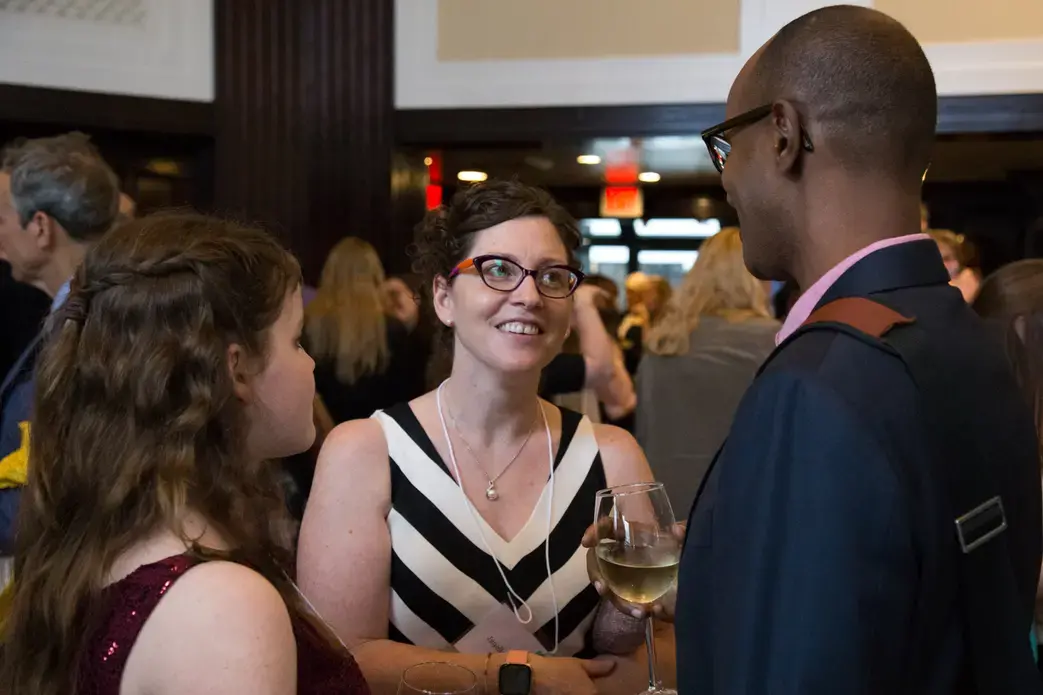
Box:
305;237;426;423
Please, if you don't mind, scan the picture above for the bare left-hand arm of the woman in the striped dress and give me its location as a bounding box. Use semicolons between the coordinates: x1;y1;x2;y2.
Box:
297;420;613;695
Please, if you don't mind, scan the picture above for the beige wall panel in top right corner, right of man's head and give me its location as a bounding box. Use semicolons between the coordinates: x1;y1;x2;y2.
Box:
873;0;1043;43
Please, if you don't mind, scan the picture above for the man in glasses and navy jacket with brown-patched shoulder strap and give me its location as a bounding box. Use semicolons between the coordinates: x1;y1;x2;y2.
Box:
676;6;1041;695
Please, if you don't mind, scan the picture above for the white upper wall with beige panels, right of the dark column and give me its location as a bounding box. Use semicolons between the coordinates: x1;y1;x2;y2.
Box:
396;0;1043;109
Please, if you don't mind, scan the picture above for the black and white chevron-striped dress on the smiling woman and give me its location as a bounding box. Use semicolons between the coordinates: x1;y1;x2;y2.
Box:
373;403;606;656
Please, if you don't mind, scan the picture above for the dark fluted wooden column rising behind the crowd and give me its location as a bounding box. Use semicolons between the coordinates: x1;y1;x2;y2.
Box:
216;0;409;282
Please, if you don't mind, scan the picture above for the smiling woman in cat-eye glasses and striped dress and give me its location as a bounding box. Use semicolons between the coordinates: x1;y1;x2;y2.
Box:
297;182;667;695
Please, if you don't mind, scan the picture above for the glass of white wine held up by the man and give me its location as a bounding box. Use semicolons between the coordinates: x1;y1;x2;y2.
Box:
595;482;681;695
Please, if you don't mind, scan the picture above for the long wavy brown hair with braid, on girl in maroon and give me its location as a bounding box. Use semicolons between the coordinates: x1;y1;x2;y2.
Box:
0;210;321;695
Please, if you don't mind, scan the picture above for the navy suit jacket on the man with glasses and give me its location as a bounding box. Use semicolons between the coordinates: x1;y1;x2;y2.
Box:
676;241;1041;695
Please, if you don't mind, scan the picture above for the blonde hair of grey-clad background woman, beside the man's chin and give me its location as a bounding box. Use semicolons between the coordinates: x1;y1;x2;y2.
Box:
646;227;771;355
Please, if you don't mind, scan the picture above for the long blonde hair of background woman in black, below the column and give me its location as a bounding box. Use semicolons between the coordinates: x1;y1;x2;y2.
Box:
305;237;390;384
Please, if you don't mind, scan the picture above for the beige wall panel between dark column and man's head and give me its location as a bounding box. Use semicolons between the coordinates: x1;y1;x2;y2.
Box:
438;0;738;61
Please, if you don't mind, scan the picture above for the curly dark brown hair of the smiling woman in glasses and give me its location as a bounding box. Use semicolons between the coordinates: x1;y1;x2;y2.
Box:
412;179;582;297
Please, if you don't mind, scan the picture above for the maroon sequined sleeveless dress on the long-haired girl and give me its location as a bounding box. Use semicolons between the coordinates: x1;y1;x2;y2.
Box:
76;555;369;695
